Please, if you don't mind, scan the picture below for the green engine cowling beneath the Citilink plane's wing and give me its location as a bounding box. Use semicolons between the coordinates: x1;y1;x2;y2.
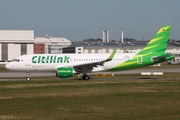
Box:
56;68;73;78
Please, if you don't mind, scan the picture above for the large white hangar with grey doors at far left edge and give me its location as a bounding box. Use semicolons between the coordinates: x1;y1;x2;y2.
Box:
0;30;34;62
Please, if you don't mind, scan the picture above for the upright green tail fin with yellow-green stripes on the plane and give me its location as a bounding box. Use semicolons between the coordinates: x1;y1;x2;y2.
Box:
137;26;171;56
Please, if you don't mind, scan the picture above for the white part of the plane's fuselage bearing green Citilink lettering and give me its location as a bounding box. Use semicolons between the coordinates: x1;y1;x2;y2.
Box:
6;53;135;72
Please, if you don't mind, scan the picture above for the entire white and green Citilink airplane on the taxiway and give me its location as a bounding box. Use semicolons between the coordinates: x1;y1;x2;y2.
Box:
5;26;174;80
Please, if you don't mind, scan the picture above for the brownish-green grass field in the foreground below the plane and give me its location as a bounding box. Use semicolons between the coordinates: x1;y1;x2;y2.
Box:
0;73;180;120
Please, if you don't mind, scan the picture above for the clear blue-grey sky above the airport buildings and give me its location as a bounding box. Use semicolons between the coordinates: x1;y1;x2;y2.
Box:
0;0;180;41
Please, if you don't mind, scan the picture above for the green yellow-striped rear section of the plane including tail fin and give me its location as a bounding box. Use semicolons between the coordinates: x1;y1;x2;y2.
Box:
109;26;174;71
